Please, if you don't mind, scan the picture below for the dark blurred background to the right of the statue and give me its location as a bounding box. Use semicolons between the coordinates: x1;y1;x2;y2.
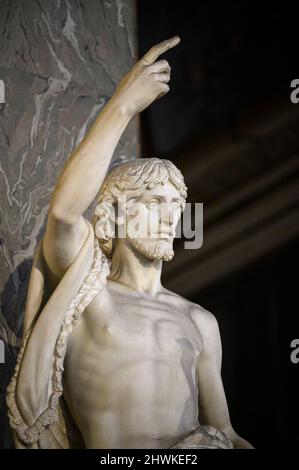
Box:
138;0;299;448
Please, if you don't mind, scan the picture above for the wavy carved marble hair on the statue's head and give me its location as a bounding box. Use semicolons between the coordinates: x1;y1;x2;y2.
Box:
93;157;187;257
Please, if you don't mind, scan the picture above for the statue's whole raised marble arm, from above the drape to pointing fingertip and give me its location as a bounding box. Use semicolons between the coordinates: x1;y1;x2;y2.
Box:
43;36;180;276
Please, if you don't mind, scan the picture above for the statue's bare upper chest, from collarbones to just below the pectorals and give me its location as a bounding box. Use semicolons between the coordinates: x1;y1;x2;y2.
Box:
68;289;202;363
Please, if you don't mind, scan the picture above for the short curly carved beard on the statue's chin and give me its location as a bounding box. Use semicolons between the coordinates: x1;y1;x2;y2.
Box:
128;237;174;261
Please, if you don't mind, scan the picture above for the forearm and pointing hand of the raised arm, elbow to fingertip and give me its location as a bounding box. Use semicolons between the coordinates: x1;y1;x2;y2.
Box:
50;36;180;224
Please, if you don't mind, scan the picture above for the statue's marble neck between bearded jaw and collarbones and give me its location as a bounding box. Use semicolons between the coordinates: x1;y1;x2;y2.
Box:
109;239;162;295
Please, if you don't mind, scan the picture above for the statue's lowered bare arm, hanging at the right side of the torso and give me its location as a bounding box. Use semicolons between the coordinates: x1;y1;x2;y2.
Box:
194;309;252;449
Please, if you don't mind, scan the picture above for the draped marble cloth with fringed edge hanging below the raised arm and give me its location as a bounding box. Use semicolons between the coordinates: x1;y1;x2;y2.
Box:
7;219;109;448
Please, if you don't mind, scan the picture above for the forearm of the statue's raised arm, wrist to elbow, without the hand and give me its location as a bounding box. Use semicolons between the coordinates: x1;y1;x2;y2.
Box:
50;97;130;222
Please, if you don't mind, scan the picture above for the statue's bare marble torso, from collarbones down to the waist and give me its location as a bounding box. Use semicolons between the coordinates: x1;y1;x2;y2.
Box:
64;281;202;449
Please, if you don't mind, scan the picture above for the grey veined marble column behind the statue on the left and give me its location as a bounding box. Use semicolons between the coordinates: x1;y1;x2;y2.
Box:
0;0;138;447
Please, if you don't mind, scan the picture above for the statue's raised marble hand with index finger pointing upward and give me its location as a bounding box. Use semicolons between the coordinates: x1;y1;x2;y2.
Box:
113;36;180;117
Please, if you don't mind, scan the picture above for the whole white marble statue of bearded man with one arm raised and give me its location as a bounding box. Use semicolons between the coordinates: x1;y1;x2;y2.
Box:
7;36;251;449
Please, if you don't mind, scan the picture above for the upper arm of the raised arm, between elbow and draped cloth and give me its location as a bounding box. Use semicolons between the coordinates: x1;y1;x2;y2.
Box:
43;211;88;278
